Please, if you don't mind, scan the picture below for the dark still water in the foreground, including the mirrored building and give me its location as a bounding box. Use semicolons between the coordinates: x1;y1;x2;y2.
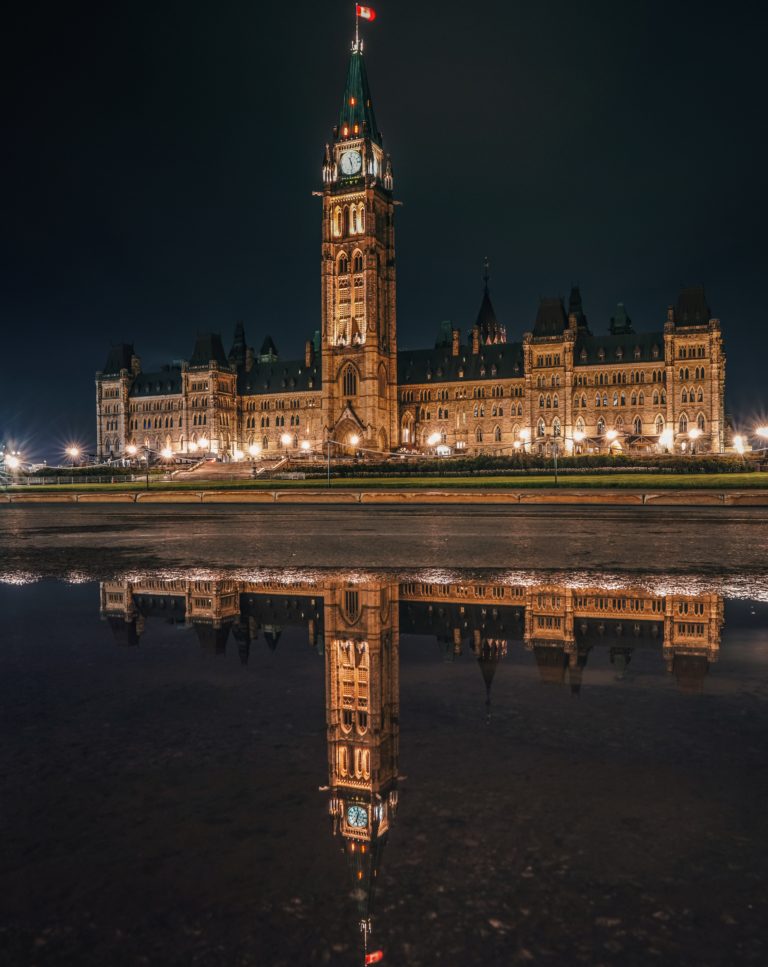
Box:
0;564;768;967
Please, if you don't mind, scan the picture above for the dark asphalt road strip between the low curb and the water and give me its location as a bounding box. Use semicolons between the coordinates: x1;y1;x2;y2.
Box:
0;505;768;577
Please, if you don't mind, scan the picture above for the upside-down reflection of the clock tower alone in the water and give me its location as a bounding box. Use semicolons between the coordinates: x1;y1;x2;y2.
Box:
324;582;399;949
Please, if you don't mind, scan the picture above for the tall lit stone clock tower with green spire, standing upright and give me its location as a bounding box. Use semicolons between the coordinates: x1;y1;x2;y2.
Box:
322;33;397;450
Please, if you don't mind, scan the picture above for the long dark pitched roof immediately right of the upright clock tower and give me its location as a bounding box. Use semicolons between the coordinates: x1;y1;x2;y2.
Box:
397;342;523;385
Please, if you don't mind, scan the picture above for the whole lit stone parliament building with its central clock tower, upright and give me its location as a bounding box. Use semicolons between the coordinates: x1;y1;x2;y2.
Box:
96;36;725;460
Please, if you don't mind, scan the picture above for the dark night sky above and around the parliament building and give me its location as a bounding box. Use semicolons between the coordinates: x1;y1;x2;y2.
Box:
6;0;768;460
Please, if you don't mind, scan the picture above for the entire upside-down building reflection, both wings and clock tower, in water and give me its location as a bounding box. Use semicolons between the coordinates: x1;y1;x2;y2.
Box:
101;573;723;950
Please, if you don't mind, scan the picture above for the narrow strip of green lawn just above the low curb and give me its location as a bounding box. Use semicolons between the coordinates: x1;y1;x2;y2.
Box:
4;473;768;493
